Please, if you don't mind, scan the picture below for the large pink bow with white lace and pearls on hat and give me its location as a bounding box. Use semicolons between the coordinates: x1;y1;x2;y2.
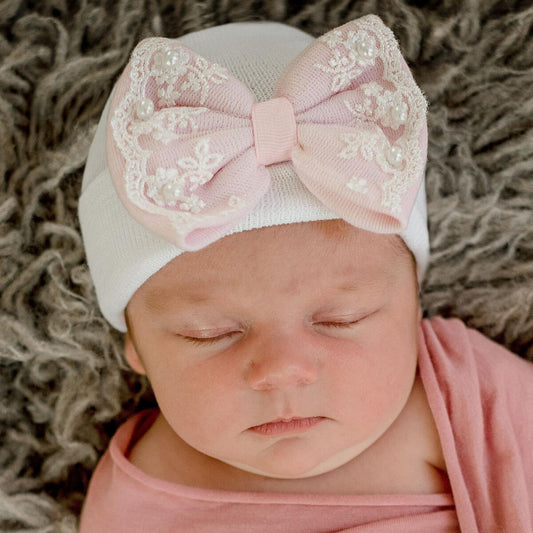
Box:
107;15;427;250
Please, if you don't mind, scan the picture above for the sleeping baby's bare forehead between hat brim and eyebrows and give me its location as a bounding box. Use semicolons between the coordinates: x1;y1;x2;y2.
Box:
132;220;409;306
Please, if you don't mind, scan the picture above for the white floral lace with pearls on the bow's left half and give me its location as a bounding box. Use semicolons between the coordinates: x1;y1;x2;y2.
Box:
111;38;242;234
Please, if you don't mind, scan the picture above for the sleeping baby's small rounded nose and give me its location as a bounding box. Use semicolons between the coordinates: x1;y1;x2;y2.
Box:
247;332;319;390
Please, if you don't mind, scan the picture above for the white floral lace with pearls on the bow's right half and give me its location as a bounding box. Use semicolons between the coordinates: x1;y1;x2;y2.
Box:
315;16;427;214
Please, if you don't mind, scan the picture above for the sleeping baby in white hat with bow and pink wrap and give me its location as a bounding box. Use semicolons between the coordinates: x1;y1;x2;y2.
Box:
80;16;533;533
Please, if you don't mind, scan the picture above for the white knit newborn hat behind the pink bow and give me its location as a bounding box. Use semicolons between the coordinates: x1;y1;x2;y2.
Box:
79;18;429;332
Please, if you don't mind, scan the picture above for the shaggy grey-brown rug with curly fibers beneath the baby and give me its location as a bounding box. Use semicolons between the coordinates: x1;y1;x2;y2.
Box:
0;0;533;533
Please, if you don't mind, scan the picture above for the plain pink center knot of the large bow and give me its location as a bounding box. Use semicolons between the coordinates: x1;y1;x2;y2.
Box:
252;96;298;165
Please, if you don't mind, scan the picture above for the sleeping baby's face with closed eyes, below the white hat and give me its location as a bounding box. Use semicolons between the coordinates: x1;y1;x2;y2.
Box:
126;221;420;478
